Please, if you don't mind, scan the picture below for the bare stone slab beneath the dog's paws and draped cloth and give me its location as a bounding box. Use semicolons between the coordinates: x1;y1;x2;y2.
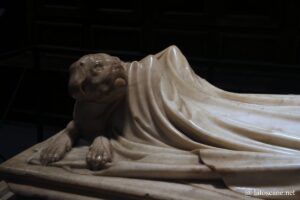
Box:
0;135;258;200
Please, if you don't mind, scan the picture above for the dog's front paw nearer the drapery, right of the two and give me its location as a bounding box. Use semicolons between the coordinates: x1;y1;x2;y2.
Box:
86;136;112;170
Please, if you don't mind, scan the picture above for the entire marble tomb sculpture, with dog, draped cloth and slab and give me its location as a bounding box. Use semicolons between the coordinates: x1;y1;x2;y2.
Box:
0;46;300;200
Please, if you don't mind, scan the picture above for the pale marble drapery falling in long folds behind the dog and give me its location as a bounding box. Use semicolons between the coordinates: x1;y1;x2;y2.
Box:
29;46;300;199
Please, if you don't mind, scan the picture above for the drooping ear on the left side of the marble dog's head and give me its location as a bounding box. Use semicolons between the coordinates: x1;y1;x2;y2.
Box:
69;62;86;99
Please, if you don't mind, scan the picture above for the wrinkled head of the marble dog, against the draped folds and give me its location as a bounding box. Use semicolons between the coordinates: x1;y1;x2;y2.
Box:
69;53;127;101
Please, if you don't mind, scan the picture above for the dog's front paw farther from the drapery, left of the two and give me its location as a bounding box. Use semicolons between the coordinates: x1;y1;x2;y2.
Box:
40;133;72;165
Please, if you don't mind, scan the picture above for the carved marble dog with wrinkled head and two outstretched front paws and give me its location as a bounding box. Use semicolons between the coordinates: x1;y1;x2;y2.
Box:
40;54;127;170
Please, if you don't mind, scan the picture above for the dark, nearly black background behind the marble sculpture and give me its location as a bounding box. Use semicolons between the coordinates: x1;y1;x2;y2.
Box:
0;0;300;162
